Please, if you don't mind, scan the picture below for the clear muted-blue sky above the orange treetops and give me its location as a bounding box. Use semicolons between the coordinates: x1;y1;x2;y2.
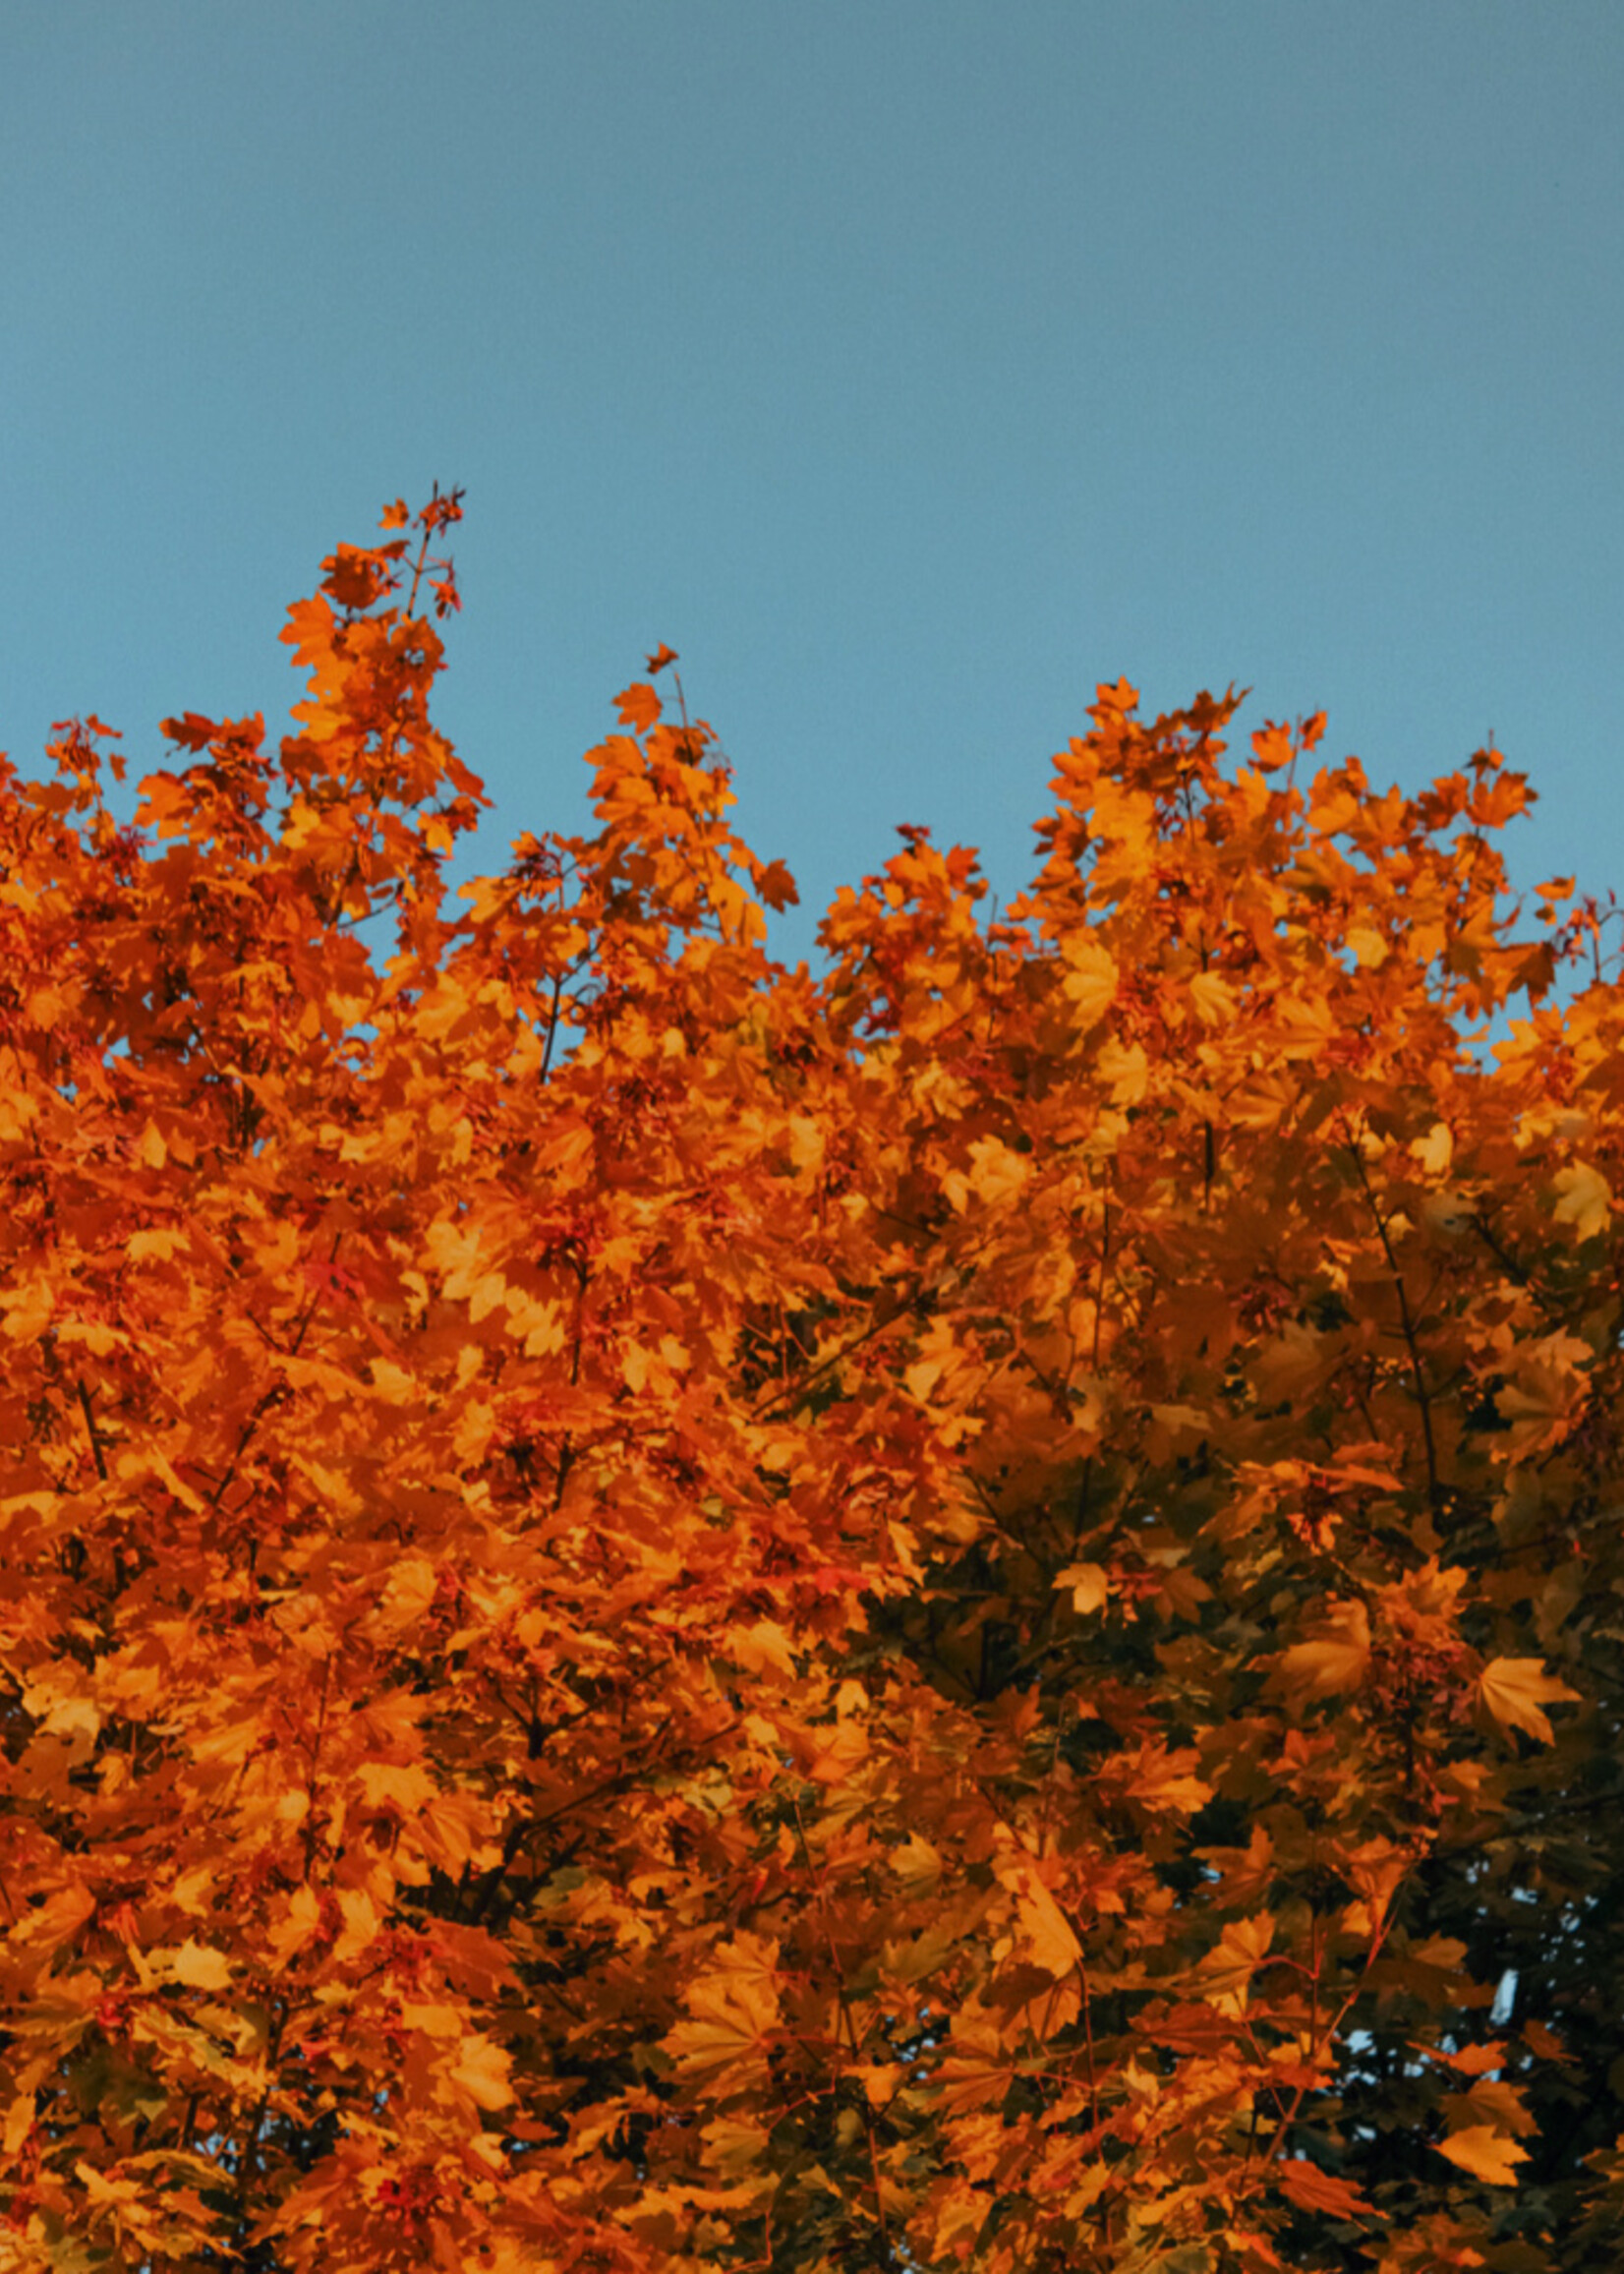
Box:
0;0;1624;953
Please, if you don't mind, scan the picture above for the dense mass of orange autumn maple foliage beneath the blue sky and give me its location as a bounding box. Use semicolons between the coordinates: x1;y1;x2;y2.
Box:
0;496;1624;2274
